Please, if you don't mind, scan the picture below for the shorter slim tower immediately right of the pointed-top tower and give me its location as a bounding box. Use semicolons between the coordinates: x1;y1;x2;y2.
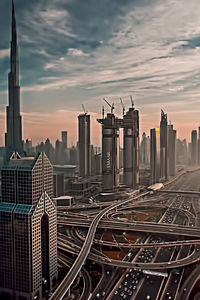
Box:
168;124;176;176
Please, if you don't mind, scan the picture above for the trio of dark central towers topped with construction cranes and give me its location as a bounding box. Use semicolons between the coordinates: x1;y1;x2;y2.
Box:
78;107;139;191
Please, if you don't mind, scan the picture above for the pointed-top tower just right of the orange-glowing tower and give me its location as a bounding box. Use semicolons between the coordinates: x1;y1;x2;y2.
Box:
160;110;169;179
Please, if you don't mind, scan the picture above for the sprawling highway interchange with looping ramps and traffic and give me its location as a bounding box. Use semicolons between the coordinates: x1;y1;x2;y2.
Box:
50;171;200;300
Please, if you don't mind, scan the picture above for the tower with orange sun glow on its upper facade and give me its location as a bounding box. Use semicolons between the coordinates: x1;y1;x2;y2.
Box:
150;128;160;184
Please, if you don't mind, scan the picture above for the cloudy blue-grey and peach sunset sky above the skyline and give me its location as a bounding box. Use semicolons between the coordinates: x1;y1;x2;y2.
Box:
0;0;200;144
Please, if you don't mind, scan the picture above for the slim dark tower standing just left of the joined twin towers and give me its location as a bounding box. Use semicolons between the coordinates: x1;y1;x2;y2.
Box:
78;113;91;178
